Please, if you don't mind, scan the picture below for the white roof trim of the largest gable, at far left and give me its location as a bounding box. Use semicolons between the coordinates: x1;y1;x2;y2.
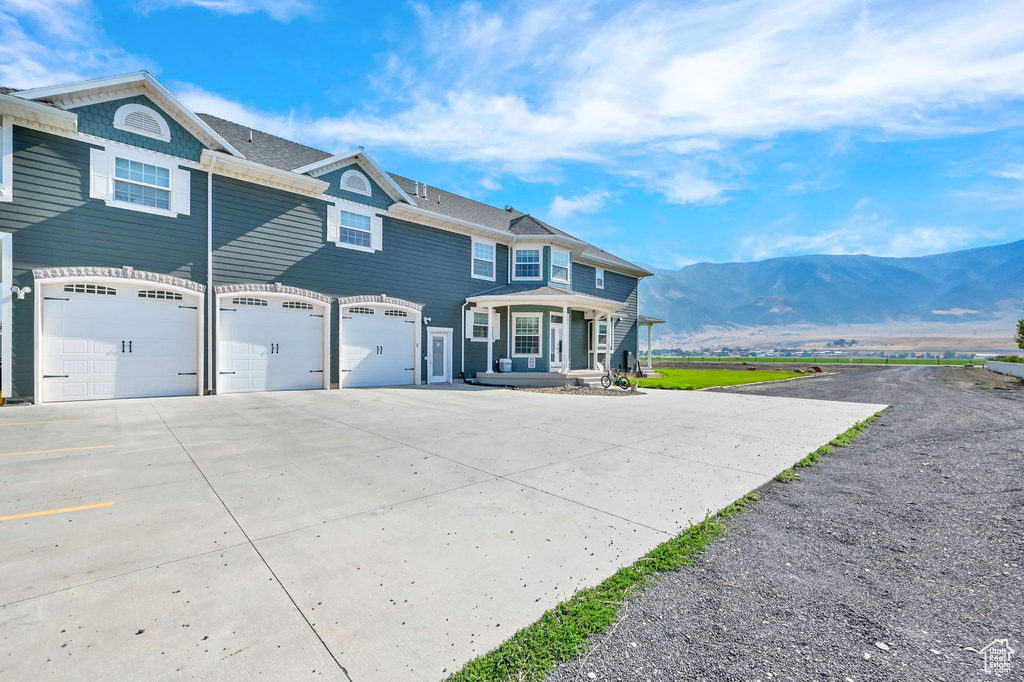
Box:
10;71;244;158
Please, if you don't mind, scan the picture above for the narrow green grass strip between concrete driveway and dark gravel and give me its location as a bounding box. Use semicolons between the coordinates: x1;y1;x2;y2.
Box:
449;405;883;682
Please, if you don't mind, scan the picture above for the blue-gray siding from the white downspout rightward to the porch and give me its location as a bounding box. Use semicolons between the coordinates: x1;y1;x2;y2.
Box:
213;177;507;383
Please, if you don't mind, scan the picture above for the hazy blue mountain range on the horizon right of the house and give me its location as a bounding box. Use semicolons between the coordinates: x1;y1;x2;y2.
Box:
640;240;1024;334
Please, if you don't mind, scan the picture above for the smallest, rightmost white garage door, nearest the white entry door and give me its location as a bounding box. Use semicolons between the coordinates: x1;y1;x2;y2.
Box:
341;306;418;388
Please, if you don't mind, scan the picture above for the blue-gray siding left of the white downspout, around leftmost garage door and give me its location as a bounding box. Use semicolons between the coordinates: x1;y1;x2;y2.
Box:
0;127;207;396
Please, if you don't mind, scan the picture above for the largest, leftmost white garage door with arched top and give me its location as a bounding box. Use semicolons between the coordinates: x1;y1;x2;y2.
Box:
42;283;201;401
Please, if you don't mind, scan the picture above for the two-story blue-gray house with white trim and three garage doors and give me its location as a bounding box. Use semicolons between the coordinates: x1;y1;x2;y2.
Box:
0;72;650;401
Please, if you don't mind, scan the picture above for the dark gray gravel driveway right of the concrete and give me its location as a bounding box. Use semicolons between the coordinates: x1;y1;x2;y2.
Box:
549;367;1024;682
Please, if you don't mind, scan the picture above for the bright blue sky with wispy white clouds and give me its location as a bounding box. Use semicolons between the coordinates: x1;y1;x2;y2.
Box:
0;0;1024;268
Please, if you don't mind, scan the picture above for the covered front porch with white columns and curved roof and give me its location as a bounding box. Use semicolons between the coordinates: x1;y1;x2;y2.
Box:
464;285;623;386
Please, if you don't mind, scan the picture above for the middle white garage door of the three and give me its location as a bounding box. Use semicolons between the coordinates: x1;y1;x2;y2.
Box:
218;295;325;393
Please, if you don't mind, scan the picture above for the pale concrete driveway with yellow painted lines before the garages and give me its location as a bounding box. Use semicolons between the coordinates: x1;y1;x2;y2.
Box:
0;379;883;682
